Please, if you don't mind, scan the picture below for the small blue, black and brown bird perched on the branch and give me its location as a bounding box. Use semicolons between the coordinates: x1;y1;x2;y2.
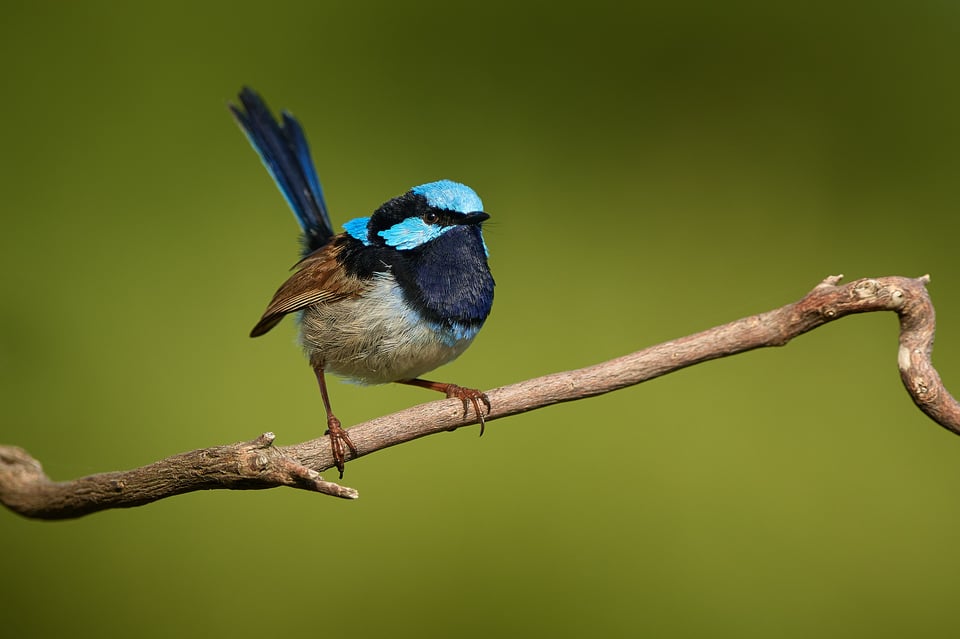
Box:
228;87;494;479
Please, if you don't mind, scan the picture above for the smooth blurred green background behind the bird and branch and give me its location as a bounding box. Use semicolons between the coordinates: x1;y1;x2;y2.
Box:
0;0;960;638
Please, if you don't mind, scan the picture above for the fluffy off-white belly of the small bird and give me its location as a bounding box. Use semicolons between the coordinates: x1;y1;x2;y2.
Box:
300;273;476;384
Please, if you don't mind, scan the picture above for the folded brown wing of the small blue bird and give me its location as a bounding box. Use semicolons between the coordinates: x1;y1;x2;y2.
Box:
250;241;366;337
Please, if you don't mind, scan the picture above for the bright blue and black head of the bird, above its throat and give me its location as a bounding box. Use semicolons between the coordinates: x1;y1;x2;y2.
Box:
343;180;490;251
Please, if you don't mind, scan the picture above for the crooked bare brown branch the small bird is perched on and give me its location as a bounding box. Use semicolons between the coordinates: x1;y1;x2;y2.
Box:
0;276;960;519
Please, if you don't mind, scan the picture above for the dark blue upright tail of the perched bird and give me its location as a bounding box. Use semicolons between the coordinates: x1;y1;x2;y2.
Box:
230;87;333;255
